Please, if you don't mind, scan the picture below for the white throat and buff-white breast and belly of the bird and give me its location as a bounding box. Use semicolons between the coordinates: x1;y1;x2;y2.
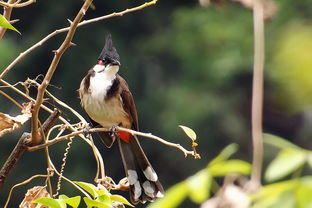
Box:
81;66;131;128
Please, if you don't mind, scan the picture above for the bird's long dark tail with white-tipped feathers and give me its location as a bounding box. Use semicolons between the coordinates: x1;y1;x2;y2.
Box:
118;136;164;204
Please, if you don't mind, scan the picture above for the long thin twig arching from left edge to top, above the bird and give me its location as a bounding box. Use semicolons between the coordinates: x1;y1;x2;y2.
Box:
0;0;158;79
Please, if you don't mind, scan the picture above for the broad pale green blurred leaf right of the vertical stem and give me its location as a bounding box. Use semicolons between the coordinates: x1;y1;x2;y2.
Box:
264;149;307;182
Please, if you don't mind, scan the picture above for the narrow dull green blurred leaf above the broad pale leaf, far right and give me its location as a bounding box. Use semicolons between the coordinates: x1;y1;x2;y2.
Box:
263;134;302;149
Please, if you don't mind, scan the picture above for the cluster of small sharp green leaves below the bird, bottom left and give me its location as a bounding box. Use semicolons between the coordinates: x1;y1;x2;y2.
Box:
33;181;133;208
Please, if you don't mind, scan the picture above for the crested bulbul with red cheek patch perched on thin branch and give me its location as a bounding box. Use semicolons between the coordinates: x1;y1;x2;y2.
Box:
79;34;164;204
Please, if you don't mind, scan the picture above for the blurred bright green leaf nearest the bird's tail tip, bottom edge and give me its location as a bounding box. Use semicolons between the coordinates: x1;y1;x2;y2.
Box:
147;181;188;208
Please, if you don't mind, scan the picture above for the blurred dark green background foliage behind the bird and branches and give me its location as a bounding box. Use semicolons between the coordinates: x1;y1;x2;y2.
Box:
0;0;312;207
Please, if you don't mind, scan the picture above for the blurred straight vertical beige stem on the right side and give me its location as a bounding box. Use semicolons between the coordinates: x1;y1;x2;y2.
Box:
249;0;264;191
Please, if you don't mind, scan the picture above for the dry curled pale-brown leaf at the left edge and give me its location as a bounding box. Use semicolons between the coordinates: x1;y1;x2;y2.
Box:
0;103;32;137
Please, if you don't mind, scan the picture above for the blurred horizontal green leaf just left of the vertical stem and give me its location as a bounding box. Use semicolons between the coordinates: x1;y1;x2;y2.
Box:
208;160;251;177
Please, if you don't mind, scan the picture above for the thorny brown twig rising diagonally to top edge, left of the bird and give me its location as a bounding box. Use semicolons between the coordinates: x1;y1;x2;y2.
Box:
31;0;92;144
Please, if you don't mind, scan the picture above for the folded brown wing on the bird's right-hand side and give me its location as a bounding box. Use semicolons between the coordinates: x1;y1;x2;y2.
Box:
117;75;139;131
